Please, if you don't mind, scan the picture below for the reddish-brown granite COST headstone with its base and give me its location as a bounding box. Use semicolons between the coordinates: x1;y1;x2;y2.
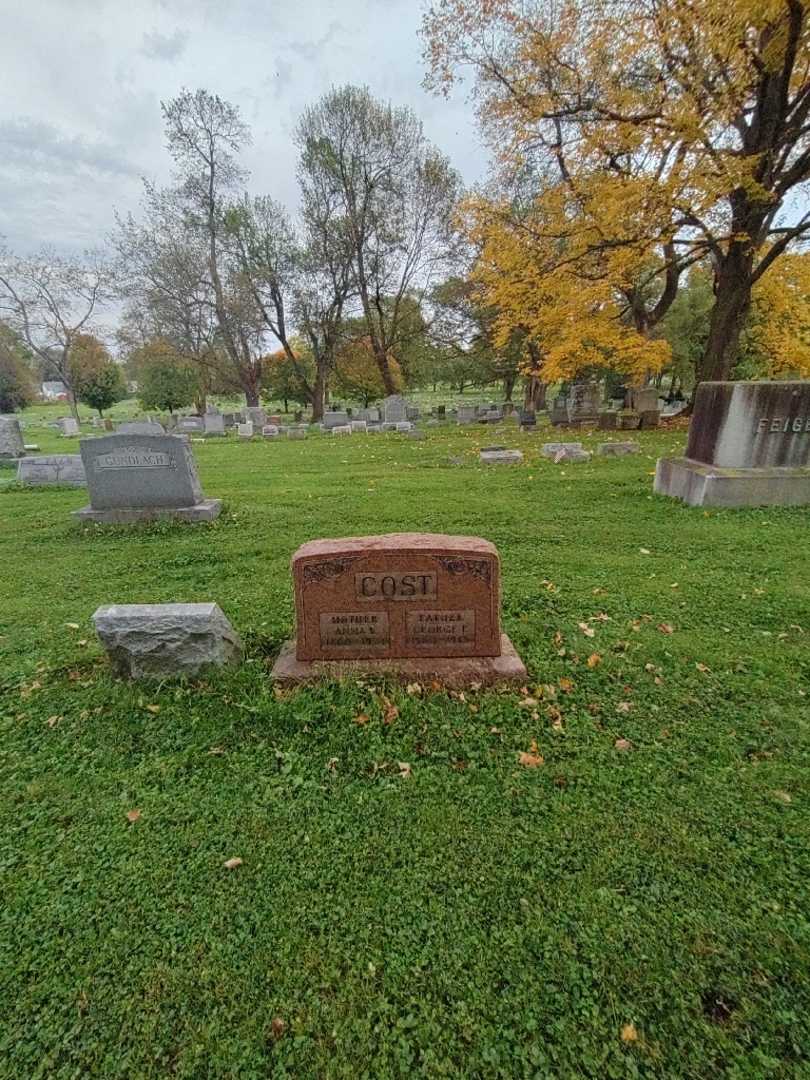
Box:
272;532;526;687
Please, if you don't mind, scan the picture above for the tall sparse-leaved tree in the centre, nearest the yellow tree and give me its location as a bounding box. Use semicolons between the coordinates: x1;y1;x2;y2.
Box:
296;86;460;393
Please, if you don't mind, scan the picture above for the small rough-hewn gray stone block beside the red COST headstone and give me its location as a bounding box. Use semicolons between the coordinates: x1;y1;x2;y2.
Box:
93;604;242;678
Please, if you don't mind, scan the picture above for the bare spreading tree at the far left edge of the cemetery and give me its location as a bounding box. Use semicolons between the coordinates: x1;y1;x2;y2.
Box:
0;248;114;420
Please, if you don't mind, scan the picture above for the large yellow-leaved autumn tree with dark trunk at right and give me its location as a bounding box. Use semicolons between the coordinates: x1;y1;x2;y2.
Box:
424;0;810;388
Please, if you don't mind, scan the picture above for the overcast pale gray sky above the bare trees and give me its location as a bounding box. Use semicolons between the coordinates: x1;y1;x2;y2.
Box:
0;0;487;254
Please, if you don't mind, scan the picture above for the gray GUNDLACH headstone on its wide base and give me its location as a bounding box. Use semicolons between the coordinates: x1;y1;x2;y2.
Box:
75;435;221;525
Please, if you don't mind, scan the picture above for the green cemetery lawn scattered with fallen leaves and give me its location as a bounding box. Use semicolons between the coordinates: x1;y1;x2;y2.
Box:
0;409;810;1080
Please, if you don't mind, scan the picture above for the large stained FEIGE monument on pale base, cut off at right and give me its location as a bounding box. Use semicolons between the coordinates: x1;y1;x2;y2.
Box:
653;381;810;508
